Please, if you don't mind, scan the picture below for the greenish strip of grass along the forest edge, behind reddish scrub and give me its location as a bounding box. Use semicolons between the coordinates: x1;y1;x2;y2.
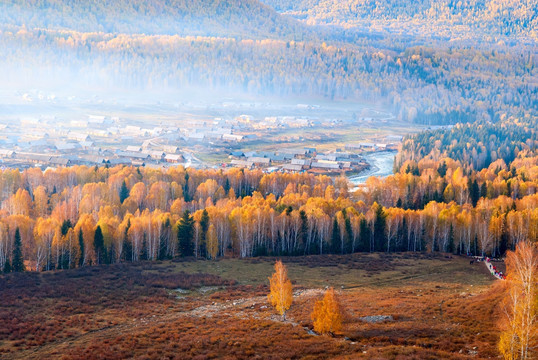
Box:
167;253;492;288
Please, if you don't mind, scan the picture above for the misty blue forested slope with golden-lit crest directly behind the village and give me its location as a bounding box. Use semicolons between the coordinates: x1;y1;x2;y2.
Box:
0;28;538;124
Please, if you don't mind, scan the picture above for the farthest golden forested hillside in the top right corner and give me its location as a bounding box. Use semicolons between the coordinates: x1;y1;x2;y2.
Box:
262;0;538;40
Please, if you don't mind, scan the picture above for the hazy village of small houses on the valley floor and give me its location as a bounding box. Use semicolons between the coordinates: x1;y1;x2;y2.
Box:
0;111;402;175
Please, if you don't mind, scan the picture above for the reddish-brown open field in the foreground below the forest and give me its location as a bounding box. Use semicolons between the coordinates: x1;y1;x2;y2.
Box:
0;254;503;359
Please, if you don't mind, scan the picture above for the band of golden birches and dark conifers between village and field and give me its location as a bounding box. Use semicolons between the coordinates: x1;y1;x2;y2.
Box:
0;119;538;271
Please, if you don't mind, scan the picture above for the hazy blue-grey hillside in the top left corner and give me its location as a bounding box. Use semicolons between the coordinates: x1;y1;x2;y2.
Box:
0;0;306;39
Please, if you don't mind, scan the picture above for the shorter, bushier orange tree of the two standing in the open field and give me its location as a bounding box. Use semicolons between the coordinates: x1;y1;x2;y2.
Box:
311;288;342;334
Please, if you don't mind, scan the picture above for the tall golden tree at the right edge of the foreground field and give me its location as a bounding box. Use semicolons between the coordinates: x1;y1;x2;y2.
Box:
499;241;538;360
